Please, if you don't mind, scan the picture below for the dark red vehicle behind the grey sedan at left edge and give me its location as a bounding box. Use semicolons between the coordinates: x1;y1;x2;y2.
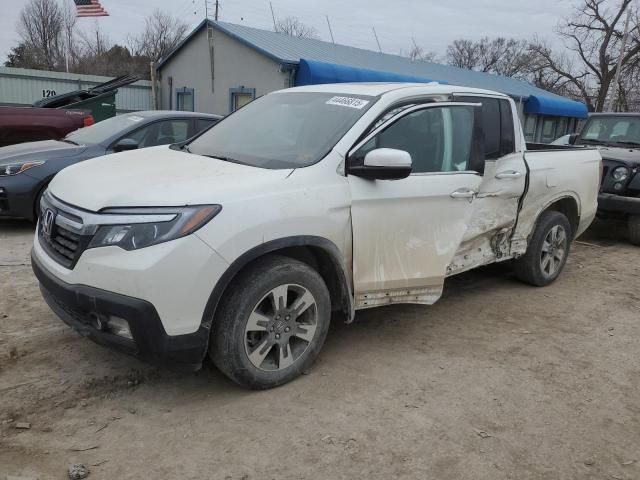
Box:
0;107;94;147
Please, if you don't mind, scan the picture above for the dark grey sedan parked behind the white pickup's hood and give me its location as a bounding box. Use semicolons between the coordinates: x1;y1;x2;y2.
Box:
0;110;222;220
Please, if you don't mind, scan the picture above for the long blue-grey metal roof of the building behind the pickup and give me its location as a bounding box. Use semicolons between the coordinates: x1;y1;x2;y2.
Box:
158;20;584;110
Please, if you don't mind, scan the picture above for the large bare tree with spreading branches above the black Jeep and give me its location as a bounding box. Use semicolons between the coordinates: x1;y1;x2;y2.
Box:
531;0;640;112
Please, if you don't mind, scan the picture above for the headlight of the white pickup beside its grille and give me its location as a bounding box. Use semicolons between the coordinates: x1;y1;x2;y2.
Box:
88;205;222;250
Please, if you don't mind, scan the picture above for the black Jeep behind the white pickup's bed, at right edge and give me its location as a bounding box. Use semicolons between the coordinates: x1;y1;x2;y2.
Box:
557;113;640;245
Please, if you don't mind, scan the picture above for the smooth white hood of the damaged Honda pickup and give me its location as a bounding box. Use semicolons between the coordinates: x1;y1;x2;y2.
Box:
49;146;291;212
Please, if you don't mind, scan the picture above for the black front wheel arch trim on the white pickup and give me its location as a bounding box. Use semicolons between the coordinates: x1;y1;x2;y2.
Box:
201;235;355;329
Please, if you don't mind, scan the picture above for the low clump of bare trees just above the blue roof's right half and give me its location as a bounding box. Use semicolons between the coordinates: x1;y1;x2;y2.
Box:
447;37;531;78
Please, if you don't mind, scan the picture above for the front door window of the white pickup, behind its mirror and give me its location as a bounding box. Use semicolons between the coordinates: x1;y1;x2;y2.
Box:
349;105;474;173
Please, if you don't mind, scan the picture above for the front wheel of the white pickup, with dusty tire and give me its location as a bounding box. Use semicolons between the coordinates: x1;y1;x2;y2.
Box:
209;255;331;389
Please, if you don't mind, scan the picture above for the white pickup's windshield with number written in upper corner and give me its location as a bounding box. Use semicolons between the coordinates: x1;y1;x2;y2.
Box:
188;92;376;169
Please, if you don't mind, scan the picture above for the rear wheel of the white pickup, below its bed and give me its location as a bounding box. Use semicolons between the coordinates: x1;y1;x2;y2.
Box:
514;211;573;287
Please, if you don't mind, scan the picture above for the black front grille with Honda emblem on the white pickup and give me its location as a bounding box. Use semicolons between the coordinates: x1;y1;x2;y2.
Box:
38;198;91;269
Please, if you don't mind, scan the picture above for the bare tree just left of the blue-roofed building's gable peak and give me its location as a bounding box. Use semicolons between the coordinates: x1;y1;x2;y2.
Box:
129;9;189;62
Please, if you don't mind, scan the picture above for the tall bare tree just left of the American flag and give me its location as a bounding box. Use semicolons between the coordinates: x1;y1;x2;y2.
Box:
18;0;64;70
